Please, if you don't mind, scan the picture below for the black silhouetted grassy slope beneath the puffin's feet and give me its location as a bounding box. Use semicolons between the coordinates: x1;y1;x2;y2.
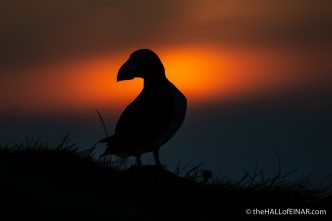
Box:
0;138;332;220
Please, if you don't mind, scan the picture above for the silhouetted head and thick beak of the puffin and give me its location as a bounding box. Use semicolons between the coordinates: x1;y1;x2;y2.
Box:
117;49;165;81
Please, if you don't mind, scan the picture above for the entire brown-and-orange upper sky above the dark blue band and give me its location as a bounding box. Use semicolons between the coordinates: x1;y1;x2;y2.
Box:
0;0;332;113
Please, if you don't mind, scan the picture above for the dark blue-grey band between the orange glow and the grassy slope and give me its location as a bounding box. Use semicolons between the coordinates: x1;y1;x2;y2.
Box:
0;88;332;185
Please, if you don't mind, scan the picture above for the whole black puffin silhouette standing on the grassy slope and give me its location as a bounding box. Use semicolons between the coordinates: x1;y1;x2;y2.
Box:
99;49;187;166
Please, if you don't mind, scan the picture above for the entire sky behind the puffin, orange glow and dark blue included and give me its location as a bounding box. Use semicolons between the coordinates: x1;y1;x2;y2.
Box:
0;0;332;185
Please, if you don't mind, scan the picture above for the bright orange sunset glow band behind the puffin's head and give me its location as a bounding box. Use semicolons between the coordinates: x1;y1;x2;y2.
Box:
0;45;330;114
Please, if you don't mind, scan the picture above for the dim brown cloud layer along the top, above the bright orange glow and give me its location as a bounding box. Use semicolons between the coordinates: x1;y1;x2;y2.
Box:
0;0;332;68
